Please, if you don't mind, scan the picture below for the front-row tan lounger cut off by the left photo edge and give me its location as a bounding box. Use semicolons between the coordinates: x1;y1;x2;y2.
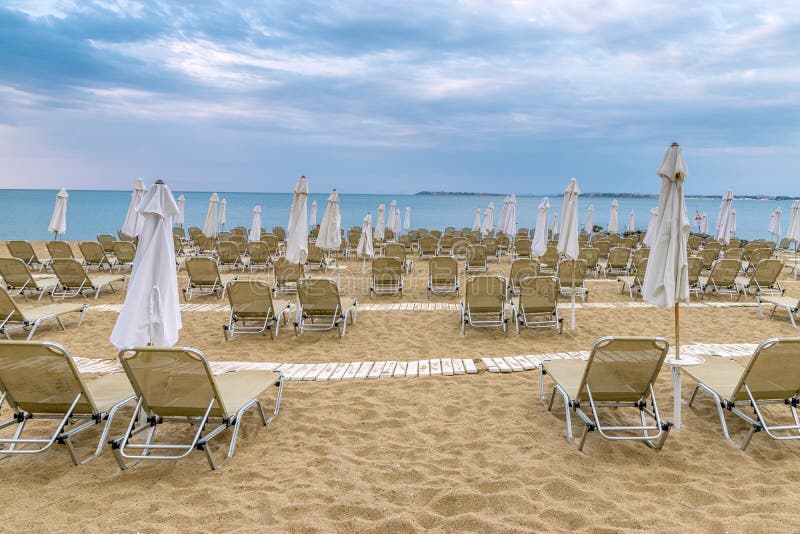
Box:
0;341;135;465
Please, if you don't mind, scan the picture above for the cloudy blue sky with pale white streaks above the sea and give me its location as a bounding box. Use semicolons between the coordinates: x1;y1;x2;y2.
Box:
0;0;800;195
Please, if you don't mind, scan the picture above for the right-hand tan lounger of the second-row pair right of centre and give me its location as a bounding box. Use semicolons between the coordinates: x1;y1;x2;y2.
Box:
511;276;562;334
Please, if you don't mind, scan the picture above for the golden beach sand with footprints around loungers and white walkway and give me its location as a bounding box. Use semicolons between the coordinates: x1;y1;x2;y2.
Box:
0;245;800;532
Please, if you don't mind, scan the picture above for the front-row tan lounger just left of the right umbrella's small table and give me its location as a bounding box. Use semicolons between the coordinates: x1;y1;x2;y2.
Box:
539;337;672;451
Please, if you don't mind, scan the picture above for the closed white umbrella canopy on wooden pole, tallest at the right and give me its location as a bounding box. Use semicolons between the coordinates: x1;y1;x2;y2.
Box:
642;143;690;306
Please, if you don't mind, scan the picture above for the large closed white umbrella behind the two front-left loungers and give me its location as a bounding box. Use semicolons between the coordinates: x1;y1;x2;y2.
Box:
111;180;182;349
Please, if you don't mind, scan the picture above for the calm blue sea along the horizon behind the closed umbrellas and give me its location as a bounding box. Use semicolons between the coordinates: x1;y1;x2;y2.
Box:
0;184;792;240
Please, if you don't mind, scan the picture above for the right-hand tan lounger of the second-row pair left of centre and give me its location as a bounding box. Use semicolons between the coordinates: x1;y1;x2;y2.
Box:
294;278;358;337
